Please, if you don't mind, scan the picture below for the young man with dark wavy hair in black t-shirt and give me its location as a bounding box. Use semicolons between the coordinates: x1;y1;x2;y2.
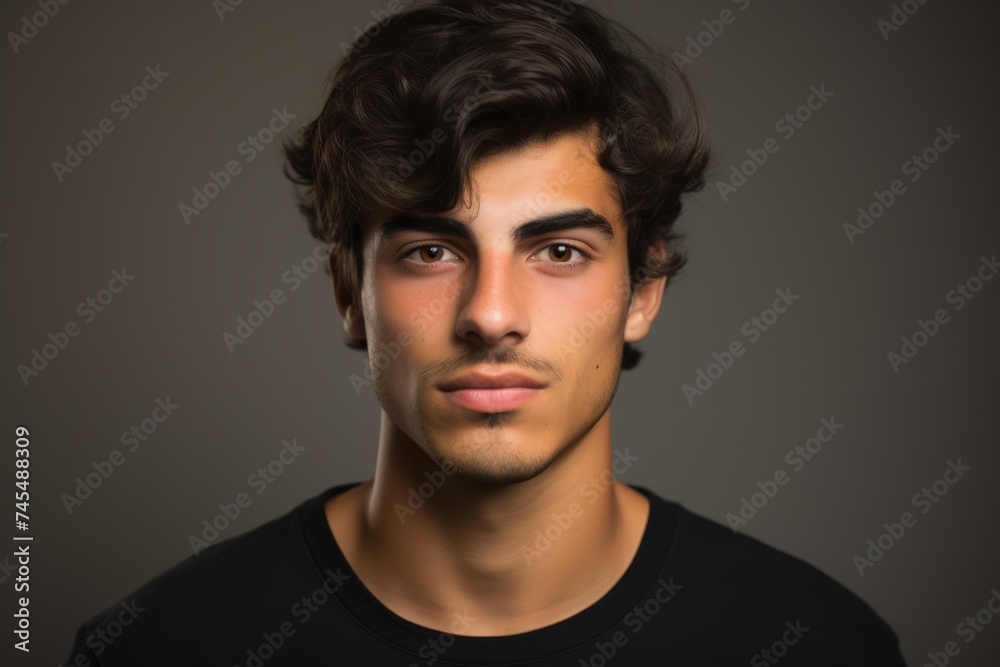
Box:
70;0;903;667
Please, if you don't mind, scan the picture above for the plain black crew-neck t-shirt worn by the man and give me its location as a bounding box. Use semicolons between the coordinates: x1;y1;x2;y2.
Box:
66;482;904;667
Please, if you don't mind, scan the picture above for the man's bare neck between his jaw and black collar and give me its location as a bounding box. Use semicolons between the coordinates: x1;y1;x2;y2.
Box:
334;412;648;636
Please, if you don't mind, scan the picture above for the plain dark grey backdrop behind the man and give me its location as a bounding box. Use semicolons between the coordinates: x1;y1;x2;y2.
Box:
0;0;1000;667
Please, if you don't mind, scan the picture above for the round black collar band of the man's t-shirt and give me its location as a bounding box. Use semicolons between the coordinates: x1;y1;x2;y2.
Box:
301;482;676;665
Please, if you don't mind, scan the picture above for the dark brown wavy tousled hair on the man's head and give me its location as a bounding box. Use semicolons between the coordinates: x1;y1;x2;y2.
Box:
283;0;709;370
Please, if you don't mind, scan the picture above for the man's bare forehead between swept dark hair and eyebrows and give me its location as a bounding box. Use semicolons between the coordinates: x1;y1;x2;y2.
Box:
364;132;624;241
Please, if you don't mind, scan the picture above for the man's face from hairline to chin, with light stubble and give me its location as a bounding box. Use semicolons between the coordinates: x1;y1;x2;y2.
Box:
348;129;663;483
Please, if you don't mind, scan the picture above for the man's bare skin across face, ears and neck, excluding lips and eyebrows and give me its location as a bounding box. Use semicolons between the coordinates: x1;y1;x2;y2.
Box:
326;126;666;636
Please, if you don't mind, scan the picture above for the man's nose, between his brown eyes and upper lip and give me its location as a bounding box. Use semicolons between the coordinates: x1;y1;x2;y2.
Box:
455;250;529;346
